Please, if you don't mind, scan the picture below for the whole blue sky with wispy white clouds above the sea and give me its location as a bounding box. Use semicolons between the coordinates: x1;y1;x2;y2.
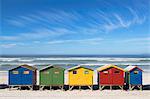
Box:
0;0;150;55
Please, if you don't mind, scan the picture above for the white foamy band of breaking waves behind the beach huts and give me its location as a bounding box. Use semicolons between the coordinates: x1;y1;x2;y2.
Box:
0;57;150;65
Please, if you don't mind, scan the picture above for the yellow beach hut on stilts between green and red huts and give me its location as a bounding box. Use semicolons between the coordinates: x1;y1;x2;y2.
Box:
68;65;93;90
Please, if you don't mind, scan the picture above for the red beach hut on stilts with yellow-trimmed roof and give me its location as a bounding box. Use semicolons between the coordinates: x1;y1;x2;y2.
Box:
97;64;124;90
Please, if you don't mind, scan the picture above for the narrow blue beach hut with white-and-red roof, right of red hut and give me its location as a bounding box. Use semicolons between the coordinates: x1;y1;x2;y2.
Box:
124;66;143;90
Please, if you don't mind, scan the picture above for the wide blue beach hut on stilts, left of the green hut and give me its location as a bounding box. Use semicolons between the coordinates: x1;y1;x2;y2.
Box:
8;64;37;89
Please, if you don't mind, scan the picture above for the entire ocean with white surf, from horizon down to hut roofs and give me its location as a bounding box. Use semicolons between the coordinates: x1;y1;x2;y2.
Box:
0;55;150;72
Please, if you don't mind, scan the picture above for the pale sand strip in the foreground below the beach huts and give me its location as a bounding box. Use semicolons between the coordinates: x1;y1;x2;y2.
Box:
0;89;150;99
